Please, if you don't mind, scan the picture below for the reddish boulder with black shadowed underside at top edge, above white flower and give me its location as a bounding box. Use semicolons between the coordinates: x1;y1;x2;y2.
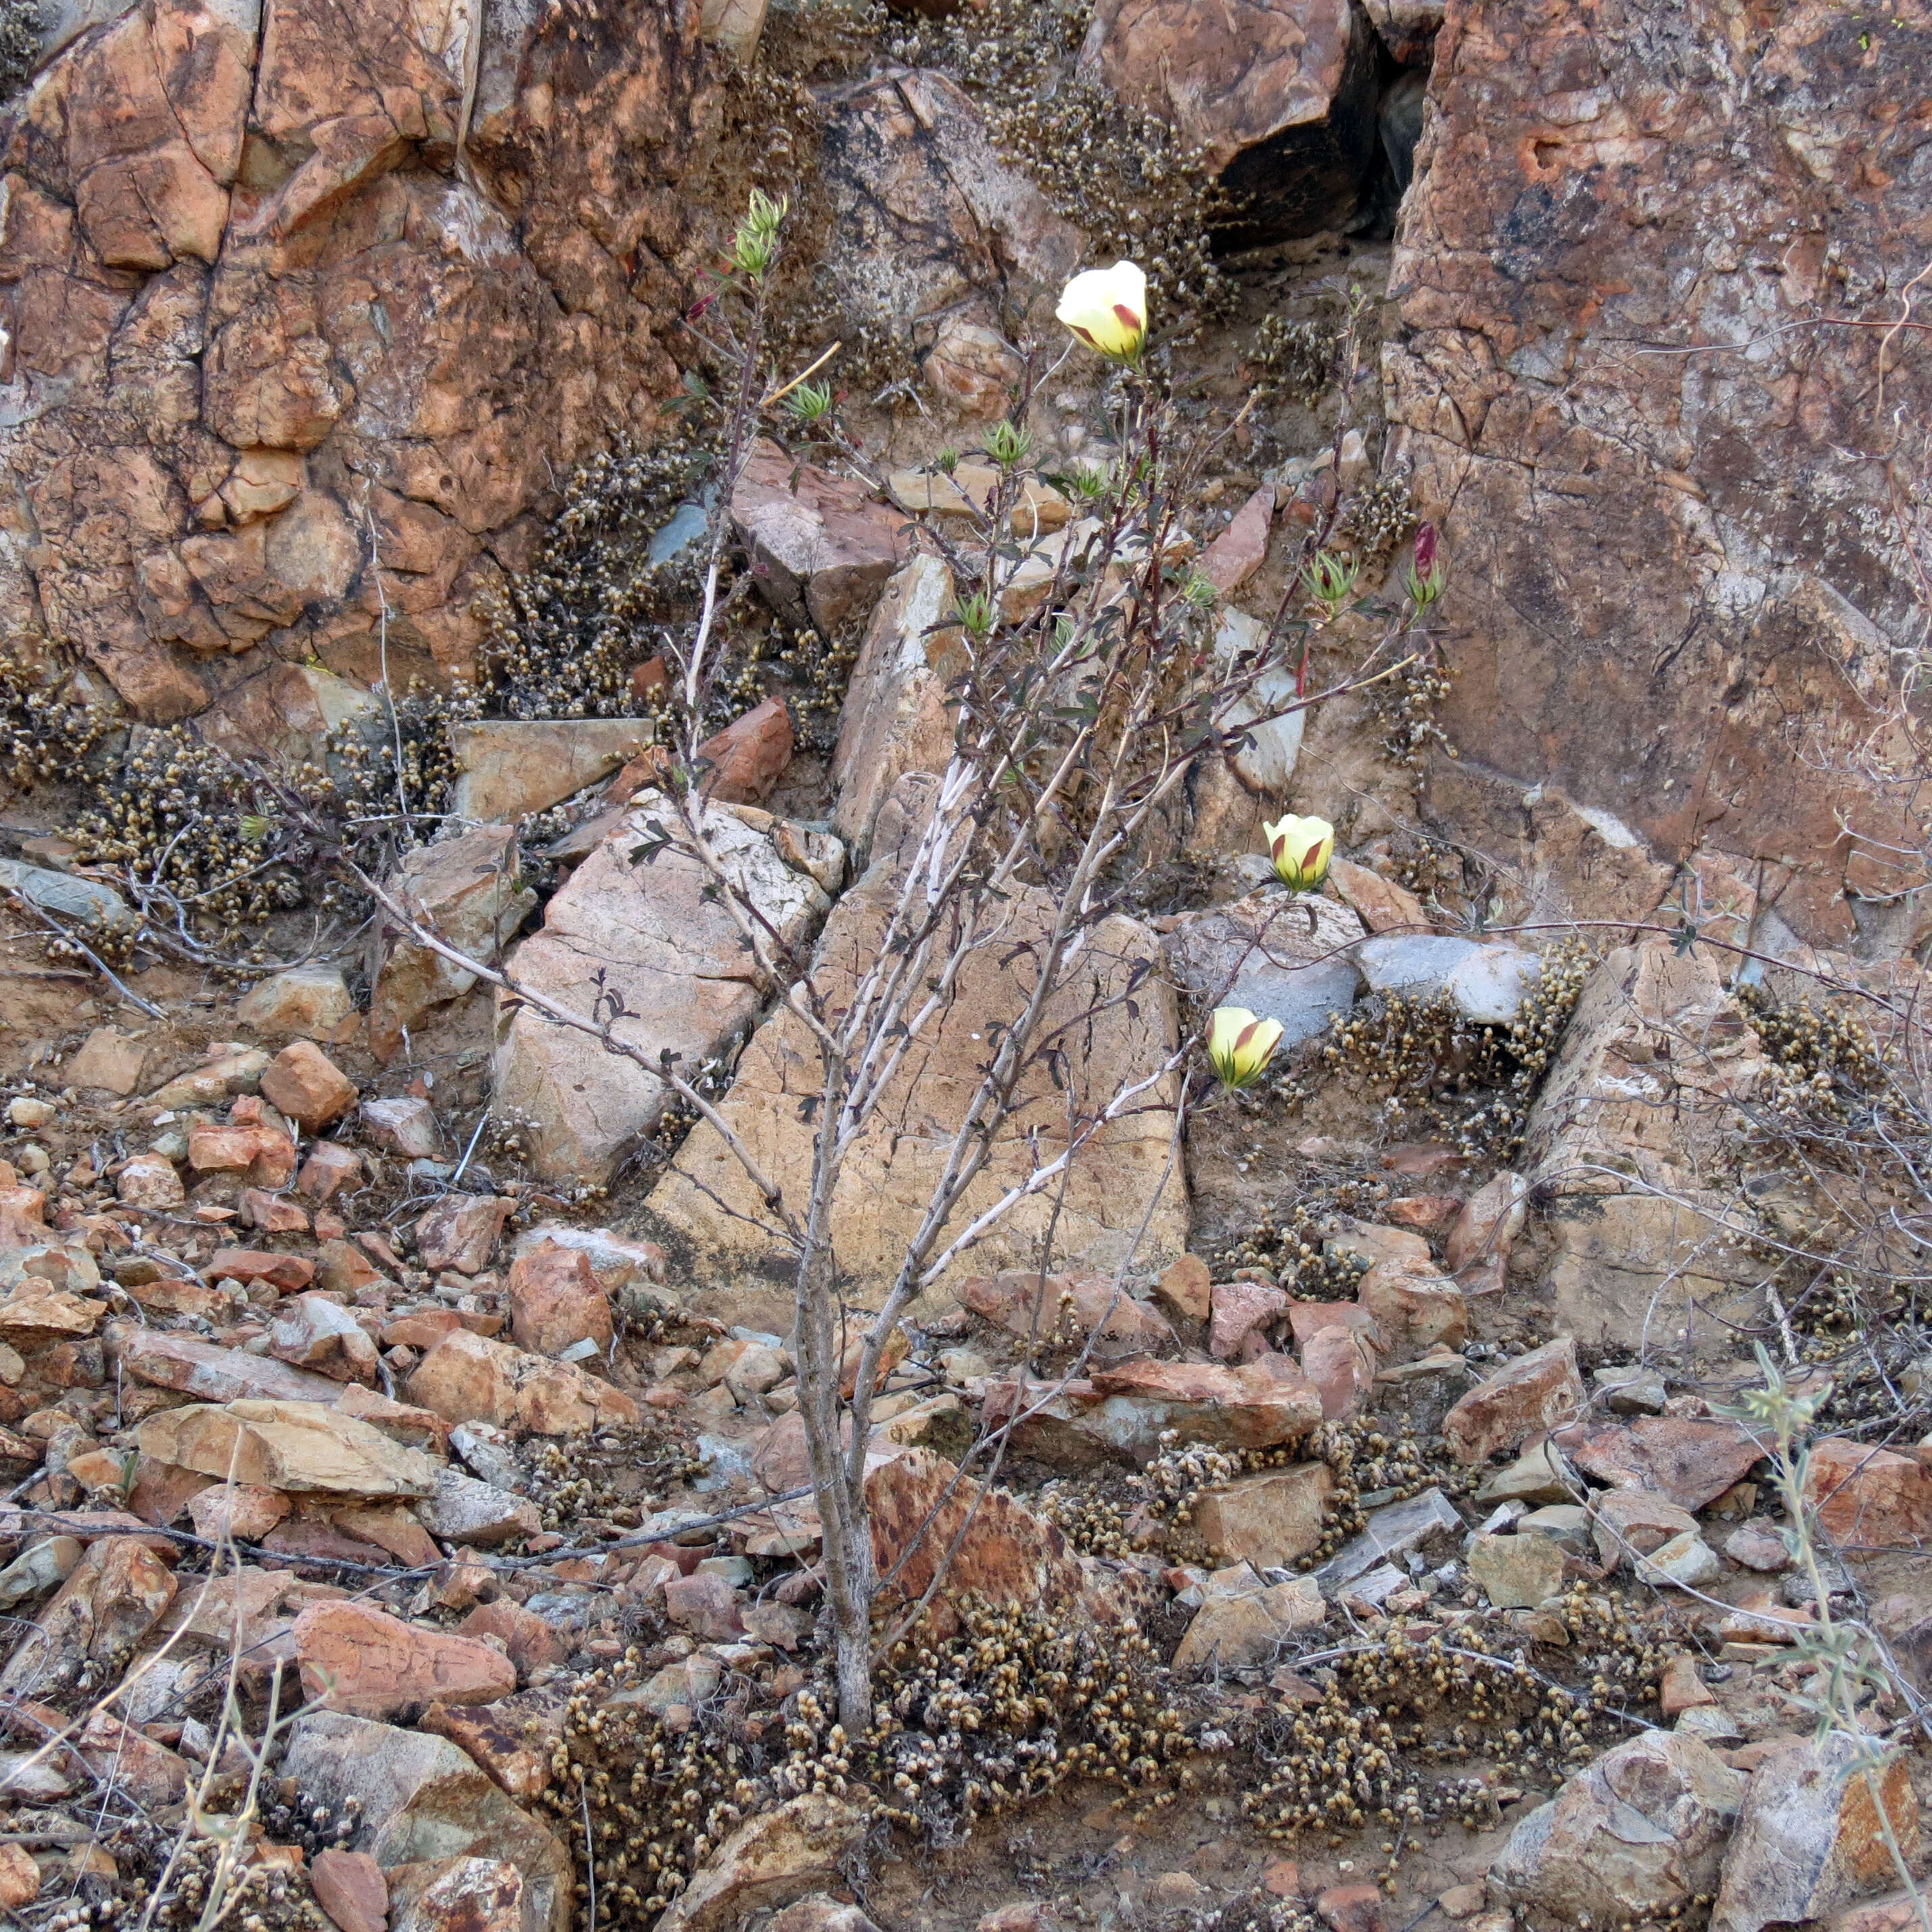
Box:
1080;0;1383;242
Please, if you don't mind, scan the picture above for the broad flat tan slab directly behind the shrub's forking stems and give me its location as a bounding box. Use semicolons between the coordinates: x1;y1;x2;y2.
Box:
649;775;1187;1295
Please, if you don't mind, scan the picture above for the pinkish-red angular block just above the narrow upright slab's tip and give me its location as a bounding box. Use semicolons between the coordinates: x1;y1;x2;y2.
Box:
731;440;906;637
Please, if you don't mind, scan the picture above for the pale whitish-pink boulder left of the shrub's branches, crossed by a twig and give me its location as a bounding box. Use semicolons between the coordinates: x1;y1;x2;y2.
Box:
497;792;831;1180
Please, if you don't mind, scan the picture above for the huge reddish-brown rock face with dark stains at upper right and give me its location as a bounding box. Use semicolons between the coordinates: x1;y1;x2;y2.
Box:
1383;0;1932;945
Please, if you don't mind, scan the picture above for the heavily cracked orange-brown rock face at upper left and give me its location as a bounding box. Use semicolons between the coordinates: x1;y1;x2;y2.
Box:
0;0;707;720
